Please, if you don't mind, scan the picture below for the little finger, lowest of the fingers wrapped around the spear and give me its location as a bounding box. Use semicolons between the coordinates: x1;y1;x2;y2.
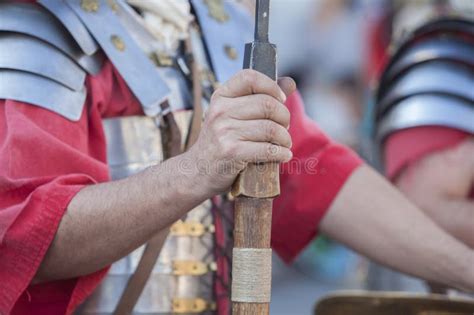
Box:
239;142;293;163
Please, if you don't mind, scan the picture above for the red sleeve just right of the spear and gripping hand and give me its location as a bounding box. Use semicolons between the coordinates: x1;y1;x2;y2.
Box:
272;93;362;262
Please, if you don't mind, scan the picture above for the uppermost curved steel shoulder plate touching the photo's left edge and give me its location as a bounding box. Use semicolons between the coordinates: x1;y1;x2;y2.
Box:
0;2;102;74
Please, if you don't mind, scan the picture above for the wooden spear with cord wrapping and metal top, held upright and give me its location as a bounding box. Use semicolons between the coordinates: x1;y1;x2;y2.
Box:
232;0;280;315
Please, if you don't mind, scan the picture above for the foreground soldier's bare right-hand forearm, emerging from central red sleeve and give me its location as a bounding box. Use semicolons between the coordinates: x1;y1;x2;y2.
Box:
321;167;474;291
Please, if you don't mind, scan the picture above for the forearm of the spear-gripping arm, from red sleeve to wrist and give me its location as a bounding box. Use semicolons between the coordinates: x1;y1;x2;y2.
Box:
35;155;209;281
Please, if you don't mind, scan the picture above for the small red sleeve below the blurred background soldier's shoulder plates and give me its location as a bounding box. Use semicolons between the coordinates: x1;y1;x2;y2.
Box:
384;126;469;180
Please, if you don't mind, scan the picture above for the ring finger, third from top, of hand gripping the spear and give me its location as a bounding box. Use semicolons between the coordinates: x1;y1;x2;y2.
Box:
234;120;292;149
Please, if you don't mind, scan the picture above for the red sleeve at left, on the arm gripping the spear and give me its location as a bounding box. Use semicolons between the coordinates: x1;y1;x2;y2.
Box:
0;63;141;314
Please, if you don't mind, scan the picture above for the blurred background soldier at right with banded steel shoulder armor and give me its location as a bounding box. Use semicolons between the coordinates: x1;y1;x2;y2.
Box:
369;9;474;293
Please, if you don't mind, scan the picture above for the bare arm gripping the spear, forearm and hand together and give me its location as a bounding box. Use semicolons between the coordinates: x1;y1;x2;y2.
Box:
34;70;295;282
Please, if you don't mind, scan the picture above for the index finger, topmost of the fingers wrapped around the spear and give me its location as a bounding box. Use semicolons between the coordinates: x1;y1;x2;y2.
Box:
215;69;286;103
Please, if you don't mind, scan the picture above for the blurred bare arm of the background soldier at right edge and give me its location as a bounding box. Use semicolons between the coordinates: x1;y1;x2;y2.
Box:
395;137;474;248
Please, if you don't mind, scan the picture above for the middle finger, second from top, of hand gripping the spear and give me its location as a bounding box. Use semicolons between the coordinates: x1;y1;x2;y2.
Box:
226;94;290;128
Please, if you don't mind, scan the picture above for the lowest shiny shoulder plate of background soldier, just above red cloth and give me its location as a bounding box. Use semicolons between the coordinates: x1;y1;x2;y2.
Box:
377;95;474;143
